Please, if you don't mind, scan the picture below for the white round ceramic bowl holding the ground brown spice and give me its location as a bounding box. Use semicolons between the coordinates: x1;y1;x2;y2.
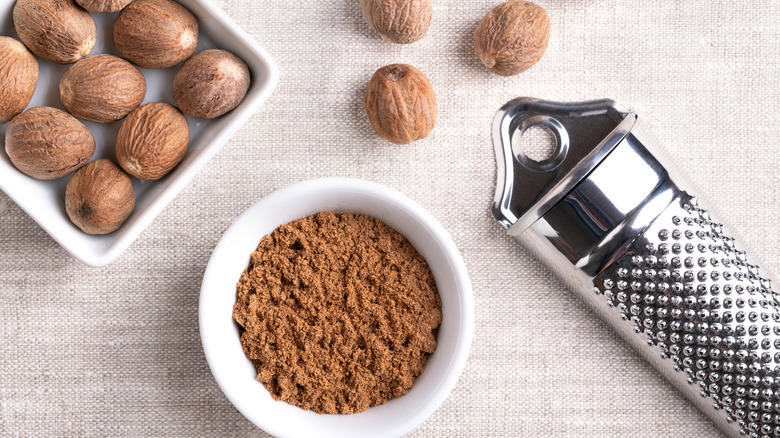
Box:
200;178;474;438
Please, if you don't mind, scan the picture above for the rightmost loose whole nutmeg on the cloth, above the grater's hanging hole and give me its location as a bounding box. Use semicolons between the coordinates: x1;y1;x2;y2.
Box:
474;0;550;76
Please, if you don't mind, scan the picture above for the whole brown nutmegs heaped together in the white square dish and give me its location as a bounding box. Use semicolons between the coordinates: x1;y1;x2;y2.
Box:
0;0;250;234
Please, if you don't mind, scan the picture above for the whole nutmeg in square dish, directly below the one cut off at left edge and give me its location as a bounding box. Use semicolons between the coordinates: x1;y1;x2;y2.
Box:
5;106;95;179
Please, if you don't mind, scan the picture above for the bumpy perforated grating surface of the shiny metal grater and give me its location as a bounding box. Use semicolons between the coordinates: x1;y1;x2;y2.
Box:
593;195;780;438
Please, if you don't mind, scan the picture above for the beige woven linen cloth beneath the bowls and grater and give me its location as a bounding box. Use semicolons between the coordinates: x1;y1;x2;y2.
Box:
0;0;780;437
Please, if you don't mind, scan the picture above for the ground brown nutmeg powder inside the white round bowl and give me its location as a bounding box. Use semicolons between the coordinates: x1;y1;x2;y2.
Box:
233;212;441;414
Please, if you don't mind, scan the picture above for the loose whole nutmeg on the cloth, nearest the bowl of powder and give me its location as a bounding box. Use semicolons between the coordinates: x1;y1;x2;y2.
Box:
363;64;437;144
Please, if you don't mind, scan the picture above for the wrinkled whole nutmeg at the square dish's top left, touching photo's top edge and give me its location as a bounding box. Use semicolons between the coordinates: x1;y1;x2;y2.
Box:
13;0;97;64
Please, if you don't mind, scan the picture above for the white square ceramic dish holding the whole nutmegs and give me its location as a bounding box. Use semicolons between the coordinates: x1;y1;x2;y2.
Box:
0;0;279;267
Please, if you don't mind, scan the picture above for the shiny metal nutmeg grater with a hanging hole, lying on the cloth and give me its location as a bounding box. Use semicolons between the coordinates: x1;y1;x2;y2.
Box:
492;98;780;437
